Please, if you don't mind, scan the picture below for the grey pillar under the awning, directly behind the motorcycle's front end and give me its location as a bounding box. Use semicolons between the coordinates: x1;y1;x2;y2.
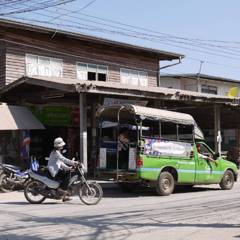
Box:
79;92;88;172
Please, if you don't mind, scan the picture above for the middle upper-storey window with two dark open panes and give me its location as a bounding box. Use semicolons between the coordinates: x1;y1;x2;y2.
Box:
77;62;108;82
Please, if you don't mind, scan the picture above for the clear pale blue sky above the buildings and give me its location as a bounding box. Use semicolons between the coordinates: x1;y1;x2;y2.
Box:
2;0;240;80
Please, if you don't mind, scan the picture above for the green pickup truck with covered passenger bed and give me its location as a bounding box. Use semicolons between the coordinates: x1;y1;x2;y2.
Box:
97;104;238;195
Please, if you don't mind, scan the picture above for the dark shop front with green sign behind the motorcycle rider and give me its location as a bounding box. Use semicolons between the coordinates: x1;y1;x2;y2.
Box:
28;105;79;161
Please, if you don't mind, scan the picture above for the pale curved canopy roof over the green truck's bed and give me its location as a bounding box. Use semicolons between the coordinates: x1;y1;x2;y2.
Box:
97;104;204;139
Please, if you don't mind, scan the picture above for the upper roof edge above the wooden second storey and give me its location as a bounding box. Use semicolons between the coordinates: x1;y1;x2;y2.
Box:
0;18;184;60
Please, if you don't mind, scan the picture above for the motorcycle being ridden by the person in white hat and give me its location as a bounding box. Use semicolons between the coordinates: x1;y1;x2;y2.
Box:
24;163;103;205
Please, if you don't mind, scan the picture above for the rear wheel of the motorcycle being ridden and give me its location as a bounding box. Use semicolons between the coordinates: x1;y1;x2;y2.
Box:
24;181;46;204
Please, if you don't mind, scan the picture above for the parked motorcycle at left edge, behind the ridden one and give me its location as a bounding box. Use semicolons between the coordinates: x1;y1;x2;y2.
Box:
0;164;29;192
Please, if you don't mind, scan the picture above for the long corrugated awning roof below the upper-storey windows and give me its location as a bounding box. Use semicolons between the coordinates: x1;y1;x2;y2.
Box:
0;77;240;105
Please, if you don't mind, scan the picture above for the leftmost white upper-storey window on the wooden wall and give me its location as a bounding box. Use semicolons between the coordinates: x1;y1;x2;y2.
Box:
26;54;63;77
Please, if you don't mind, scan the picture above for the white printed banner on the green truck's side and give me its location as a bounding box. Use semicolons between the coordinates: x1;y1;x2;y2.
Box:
144;139;192;157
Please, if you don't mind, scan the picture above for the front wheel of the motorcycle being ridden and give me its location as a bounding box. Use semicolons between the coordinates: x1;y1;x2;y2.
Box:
78;182;103;205
